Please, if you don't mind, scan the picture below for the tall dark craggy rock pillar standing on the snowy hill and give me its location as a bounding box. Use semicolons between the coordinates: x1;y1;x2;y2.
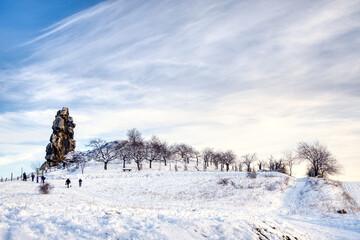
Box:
45;107;76;166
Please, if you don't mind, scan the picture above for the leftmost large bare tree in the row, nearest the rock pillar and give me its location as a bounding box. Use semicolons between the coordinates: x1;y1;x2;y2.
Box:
87;138;118;170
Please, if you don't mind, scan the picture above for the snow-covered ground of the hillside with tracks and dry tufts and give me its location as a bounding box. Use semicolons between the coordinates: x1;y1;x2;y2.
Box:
0;164;360;240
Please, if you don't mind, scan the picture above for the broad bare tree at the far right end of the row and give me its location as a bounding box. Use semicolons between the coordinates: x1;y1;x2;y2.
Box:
297;141;342;177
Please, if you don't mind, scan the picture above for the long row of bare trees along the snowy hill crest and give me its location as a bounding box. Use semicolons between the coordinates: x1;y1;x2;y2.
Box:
69;128;341;176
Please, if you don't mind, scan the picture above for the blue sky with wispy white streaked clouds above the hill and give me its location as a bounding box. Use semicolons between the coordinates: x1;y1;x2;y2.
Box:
0;0;360;181
